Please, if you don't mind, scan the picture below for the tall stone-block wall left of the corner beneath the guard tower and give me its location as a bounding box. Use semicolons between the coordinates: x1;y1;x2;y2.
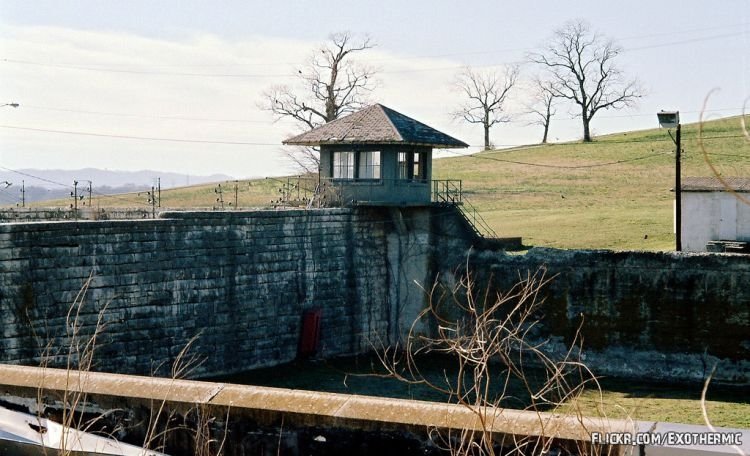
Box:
0;209;446;375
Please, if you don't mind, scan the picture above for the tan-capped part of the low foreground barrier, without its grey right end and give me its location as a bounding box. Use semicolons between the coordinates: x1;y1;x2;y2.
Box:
0;365;634;454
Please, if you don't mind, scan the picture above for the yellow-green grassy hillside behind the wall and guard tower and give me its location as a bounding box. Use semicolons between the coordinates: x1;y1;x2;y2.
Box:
26;114;750;250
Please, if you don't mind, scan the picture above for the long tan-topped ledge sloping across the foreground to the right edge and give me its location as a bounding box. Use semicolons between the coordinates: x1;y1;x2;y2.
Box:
0;365;750;455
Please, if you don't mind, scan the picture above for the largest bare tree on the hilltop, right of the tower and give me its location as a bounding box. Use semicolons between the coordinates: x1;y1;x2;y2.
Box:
529;21;642;142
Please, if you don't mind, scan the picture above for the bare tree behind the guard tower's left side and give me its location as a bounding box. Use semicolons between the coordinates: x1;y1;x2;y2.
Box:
259;32;376;172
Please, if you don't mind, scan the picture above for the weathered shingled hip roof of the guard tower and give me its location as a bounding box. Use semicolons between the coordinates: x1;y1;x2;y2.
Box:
283;104;469;148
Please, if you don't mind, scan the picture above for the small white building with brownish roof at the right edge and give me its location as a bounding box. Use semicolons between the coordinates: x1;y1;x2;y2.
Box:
681;177;750;252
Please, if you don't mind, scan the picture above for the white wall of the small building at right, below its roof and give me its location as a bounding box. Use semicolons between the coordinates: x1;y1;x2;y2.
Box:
682;192;750;252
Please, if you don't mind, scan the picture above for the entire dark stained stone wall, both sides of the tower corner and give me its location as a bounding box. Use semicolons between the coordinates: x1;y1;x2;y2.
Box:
0;207;750;383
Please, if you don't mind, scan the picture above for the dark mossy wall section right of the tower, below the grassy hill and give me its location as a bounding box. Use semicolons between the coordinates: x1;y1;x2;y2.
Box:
464;249;750;384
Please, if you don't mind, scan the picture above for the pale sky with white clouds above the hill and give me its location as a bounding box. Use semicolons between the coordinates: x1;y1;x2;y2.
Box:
0;0;750;185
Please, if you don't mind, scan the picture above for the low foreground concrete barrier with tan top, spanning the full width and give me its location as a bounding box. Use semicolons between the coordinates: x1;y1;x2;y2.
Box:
0;365;750;456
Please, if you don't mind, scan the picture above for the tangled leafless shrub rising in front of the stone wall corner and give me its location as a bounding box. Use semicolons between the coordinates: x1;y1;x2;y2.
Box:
377;266;600;456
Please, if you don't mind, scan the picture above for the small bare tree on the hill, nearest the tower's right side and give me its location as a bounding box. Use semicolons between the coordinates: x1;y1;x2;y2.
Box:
453;66;519;150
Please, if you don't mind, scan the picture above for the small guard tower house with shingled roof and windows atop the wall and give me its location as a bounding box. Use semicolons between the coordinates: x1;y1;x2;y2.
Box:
283;104;468;206
